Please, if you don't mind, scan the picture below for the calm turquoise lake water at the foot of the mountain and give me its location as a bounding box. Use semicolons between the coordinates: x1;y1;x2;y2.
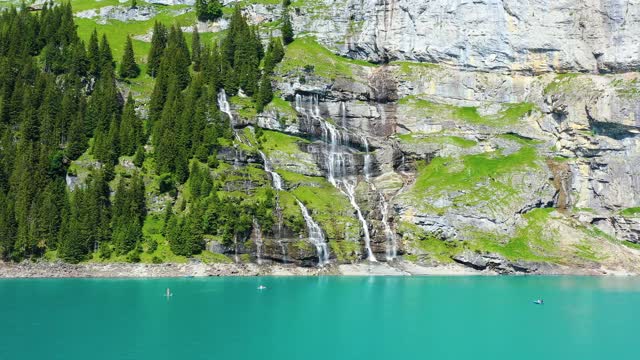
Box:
0;277;640;360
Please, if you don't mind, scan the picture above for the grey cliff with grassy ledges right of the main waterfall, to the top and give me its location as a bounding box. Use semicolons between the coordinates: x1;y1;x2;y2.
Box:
221;0;640;268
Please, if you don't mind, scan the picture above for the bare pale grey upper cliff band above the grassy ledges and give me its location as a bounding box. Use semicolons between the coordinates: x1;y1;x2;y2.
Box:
296;0;640;74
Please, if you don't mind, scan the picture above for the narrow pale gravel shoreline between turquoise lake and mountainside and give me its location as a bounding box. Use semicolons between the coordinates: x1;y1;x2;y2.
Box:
0;260;639;279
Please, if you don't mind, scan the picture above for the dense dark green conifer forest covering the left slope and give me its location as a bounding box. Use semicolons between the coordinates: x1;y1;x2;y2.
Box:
0;1;284;262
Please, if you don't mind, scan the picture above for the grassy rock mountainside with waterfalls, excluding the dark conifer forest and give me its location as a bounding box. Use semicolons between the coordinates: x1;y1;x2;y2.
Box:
5;0;640;272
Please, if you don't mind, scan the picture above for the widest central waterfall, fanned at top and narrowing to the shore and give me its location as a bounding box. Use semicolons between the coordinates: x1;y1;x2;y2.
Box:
296;94;377;262
